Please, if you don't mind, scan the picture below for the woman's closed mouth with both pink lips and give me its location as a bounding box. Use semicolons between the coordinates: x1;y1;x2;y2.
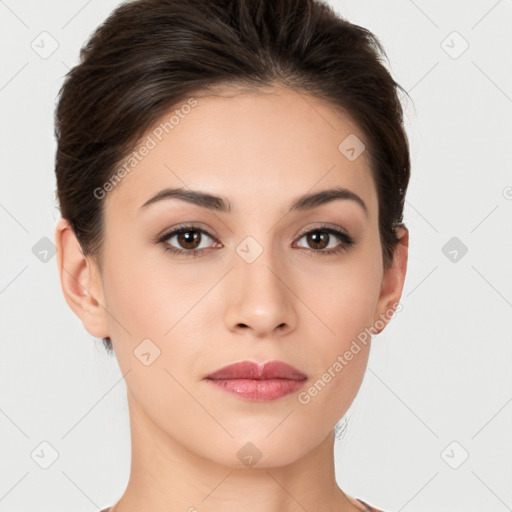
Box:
206;361;308;401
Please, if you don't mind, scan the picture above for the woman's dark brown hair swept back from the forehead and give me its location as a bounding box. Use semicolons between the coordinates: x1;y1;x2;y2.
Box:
55;0;410;351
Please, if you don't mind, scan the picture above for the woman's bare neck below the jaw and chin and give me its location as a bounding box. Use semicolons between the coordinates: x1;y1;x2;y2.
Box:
112;393;362;512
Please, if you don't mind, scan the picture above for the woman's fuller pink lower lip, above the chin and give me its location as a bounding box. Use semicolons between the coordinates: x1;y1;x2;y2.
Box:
208;379;307;402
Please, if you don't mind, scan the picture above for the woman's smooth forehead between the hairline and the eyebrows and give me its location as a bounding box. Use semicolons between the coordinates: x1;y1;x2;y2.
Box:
107;87;377;220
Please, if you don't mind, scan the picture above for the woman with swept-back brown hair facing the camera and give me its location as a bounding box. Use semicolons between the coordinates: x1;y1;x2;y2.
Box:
55;0;410;512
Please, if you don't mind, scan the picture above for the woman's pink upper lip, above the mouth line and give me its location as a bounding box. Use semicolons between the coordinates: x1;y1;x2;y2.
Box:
206;361;307;380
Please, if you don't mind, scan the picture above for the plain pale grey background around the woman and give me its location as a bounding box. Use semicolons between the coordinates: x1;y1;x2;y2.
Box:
0;0;512;512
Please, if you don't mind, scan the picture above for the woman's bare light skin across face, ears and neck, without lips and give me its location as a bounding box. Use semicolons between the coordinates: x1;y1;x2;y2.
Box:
55;86;408;512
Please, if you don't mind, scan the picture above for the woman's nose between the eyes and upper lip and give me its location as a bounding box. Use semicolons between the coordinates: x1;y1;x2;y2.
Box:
224;241;298;338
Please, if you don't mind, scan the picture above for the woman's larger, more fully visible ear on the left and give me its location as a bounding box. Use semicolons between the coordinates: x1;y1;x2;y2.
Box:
55;218;109;338
